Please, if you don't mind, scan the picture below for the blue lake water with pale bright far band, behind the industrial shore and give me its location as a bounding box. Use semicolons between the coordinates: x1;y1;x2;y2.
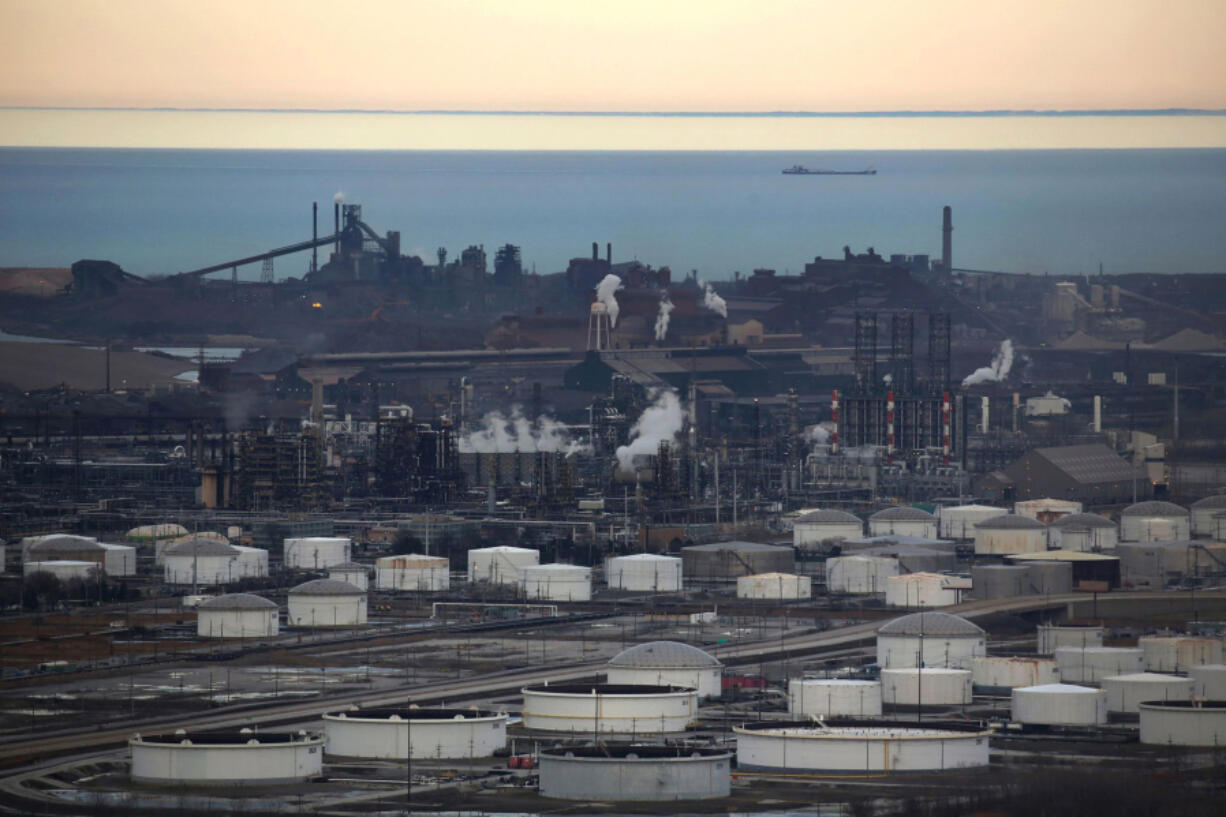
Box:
0;110;1226;280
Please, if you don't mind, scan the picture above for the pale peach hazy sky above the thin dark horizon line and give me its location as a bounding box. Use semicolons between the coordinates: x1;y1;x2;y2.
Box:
0;0;1226;110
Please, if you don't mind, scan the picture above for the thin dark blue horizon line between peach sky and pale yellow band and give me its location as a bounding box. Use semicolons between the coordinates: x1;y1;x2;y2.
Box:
7;105;1226;119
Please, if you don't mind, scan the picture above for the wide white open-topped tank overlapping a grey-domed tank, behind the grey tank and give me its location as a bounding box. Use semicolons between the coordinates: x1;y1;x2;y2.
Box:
522;683;698;736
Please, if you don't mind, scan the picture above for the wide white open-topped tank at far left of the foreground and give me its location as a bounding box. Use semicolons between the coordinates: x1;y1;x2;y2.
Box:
128;729;324;786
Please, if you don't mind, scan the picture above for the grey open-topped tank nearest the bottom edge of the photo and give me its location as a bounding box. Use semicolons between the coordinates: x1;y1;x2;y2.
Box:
538;743;732;802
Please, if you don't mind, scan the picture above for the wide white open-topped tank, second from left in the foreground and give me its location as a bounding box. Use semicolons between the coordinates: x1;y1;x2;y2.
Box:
324;707;506;761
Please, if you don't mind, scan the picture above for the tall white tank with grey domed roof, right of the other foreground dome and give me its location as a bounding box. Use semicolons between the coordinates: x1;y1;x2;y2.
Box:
877;612;987;670
